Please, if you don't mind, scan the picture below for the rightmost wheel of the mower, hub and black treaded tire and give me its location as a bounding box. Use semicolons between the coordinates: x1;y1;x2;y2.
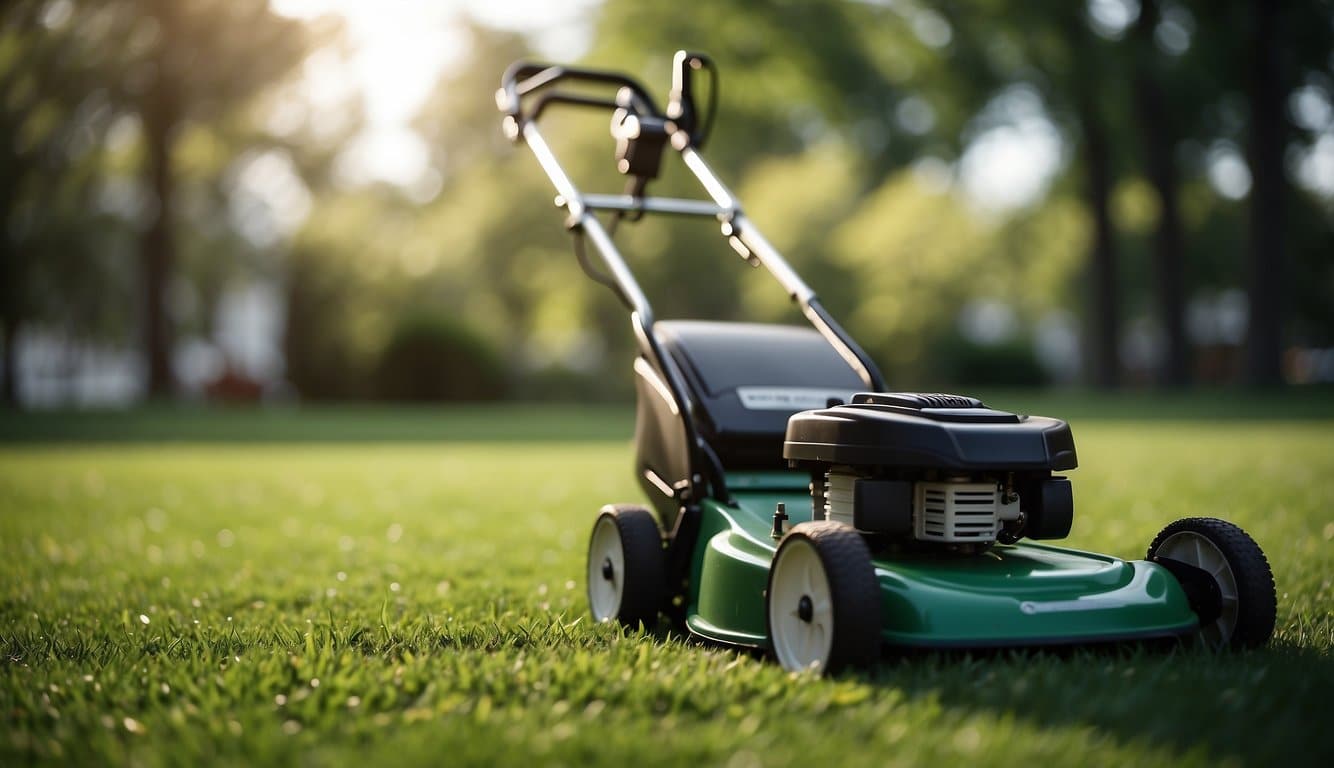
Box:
1149;517;1278;648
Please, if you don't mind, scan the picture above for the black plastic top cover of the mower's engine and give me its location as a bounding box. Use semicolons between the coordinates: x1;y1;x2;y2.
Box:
783;395;1078;472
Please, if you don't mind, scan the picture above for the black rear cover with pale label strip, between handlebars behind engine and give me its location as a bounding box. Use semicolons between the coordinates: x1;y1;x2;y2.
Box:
654;320;866;469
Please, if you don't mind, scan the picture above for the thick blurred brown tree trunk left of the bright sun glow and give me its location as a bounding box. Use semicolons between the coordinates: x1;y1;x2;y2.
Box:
140;48;177;400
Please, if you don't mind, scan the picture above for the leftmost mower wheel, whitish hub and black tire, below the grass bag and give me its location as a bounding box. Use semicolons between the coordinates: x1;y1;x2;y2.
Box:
587;504;666;629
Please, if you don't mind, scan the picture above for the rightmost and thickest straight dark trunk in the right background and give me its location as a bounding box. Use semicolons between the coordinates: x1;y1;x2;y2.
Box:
1246;0;1285;387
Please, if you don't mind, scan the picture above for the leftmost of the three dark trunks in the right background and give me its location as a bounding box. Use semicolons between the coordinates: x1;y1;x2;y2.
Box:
1079;99;1121;389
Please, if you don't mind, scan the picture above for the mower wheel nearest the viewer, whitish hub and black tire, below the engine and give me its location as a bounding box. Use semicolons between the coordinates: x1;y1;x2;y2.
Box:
764;520;880;673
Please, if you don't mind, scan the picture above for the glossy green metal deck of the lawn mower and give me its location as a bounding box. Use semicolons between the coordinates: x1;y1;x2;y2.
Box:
686;482;1199;648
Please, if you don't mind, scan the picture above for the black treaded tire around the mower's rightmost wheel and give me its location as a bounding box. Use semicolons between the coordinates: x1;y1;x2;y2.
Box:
1149;517;1278;648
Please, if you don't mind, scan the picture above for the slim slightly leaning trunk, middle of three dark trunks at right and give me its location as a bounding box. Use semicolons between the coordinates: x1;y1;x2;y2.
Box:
1135;0;1190;388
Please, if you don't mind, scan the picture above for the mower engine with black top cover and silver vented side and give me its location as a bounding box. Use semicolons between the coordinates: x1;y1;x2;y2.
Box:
783;393;1077;552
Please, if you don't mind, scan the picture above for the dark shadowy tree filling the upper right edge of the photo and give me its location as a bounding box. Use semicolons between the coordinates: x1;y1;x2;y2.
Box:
1165;0;1334;387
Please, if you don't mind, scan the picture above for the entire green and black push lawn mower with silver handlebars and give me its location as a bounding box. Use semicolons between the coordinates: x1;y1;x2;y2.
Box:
496;51;1277;673
